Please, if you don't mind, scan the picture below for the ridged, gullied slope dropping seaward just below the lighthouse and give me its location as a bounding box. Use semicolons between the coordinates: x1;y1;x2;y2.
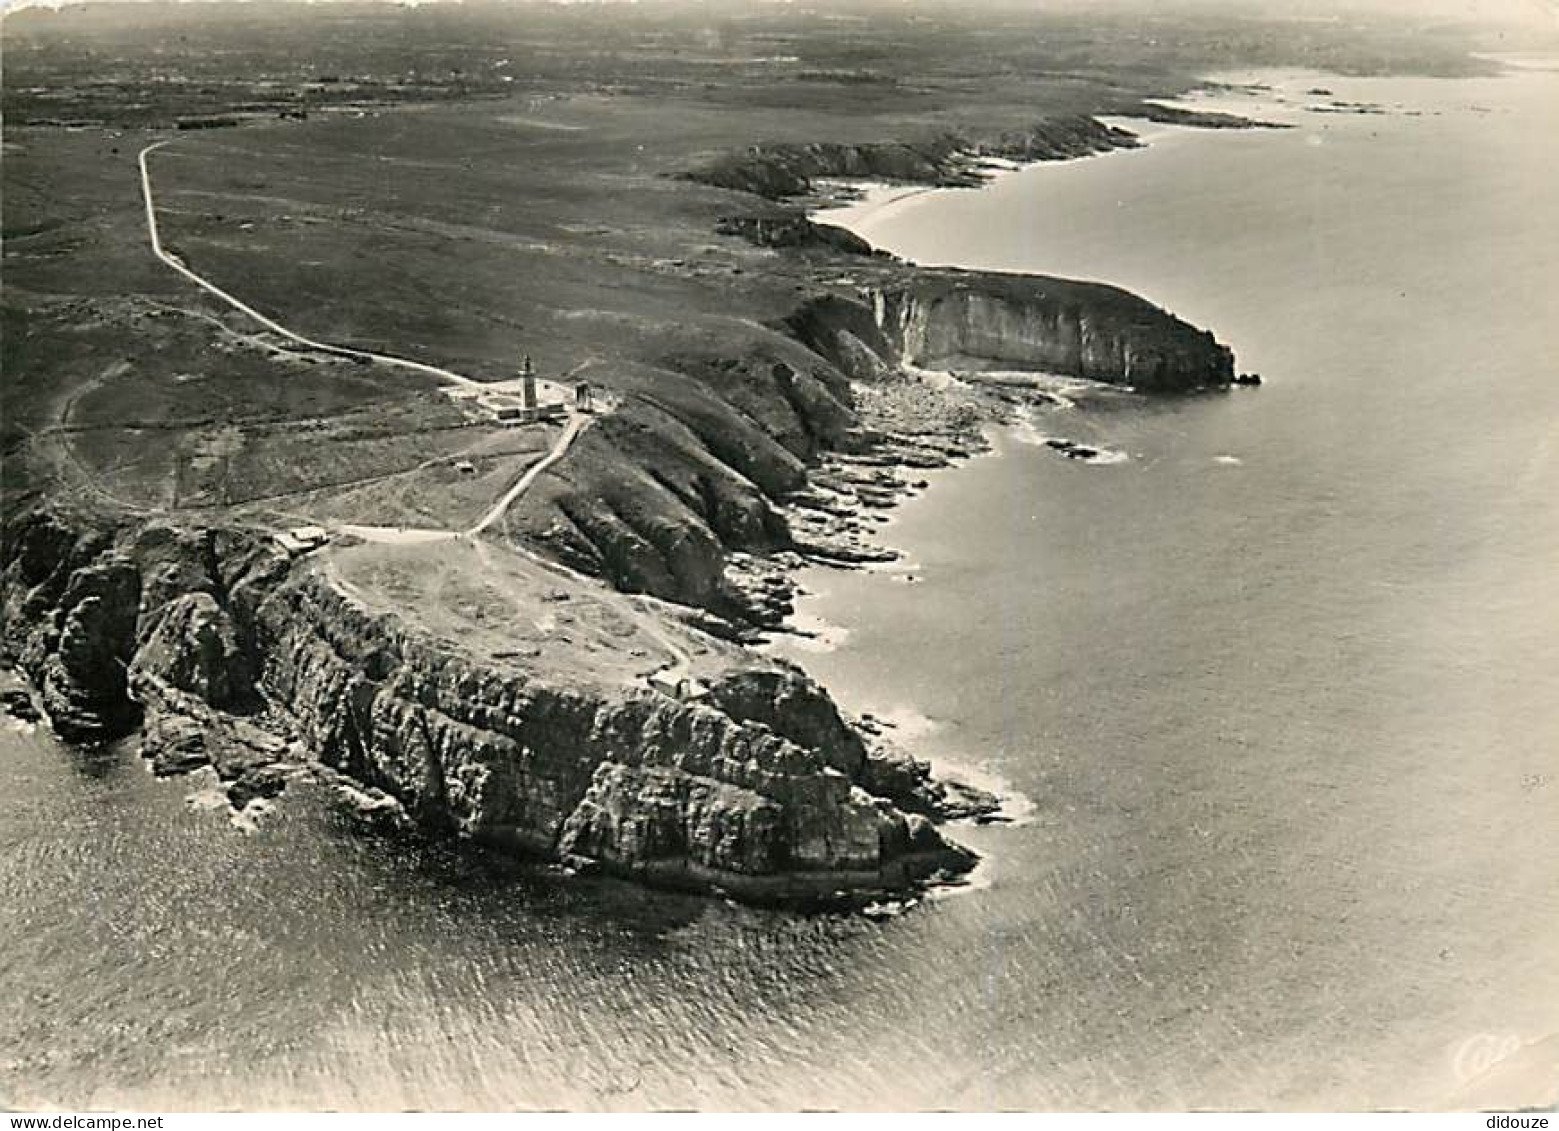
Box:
527;340;856;621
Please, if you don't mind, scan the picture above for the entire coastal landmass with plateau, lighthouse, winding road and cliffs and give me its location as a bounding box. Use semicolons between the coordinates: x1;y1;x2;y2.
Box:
0;5;1521;902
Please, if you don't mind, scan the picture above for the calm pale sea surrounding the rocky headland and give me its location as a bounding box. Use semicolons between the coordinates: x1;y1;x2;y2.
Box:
0;70;1559;1108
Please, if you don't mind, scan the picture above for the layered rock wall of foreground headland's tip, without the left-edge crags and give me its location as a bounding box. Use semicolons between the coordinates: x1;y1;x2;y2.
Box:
260;574;970;897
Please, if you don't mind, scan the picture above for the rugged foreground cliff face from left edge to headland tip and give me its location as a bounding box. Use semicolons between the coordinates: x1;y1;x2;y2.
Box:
0;512;973;899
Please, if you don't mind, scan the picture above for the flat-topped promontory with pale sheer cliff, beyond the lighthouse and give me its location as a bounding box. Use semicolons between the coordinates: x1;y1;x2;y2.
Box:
790;270;1235;393
